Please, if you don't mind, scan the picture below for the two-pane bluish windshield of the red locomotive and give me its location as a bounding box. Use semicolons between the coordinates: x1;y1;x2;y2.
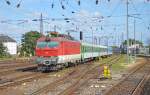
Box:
37;42;59;48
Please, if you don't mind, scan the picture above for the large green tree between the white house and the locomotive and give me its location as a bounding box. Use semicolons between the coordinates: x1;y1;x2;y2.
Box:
20;31;42;56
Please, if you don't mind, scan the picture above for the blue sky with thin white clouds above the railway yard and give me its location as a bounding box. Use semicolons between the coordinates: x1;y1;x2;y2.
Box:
0;0;150;45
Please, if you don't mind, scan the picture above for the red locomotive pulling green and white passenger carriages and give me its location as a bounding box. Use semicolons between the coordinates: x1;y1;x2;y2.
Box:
35;32;112;71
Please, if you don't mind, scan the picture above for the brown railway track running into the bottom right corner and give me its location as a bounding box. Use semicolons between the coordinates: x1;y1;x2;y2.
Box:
104;60;150;95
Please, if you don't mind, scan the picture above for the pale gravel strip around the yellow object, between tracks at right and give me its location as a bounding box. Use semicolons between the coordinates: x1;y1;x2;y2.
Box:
74;59;144;95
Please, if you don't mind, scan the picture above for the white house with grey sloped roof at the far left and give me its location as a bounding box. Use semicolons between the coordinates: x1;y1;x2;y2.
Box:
0;34;17;55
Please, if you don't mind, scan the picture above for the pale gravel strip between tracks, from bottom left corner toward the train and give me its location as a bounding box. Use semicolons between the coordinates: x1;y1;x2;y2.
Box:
0;69;74;95
